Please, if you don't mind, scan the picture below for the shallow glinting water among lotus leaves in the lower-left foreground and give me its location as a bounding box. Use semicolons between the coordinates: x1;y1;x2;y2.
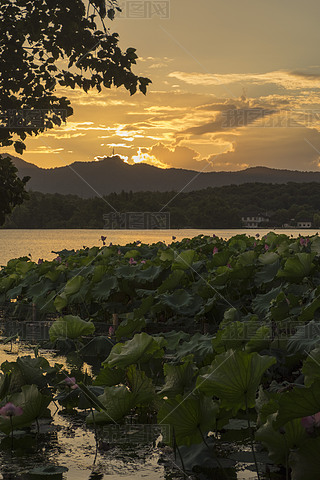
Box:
0;337;263;480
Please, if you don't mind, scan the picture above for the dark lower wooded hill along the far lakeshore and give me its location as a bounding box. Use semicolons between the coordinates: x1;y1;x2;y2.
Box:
4;182;320;229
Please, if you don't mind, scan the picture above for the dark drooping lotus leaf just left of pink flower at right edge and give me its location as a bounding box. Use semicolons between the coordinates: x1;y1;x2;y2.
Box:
255;413;308;465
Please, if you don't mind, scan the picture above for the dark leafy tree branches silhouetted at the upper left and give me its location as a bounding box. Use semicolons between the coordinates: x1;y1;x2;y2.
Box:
0;0;151;224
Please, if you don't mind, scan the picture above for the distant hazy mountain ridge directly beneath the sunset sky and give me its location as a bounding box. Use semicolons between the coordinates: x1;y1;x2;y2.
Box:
6;156;320;198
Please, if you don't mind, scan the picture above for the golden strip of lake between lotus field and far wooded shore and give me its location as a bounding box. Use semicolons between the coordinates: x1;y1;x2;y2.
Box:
0;228;318;266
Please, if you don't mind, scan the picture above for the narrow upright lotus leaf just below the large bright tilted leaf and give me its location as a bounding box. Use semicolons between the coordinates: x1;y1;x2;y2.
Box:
127;365;155;405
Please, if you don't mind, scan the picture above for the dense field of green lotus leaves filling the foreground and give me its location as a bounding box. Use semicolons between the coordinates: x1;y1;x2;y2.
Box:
0;232;320;480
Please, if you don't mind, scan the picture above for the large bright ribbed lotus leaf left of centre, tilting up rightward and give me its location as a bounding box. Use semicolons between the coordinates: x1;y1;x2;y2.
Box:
105;332;165;368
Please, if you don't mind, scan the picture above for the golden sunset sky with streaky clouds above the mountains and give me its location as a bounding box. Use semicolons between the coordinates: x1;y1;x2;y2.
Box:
5;0;320;171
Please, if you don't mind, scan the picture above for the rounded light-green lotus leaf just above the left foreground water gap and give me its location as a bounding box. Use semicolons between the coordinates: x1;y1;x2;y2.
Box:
49;315;95;342
